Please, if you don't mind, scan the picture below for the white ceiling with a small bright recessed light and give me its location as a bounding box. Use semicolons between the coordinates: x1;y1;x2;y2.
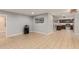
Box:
3;9;67;16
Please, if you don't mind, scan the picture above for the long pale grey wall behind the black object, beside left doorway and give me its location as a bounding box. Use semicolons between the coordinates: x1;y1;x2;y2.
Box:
0;11;32;36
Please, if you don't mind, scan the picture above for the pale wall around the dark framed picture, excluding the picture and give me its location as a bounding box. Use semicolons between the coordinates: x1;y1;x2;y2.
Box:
33;14;53;34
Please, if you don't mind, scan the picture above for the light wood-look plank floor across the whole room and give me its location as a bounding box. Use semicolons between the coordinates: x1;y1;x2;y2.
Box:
0;30;79;49
